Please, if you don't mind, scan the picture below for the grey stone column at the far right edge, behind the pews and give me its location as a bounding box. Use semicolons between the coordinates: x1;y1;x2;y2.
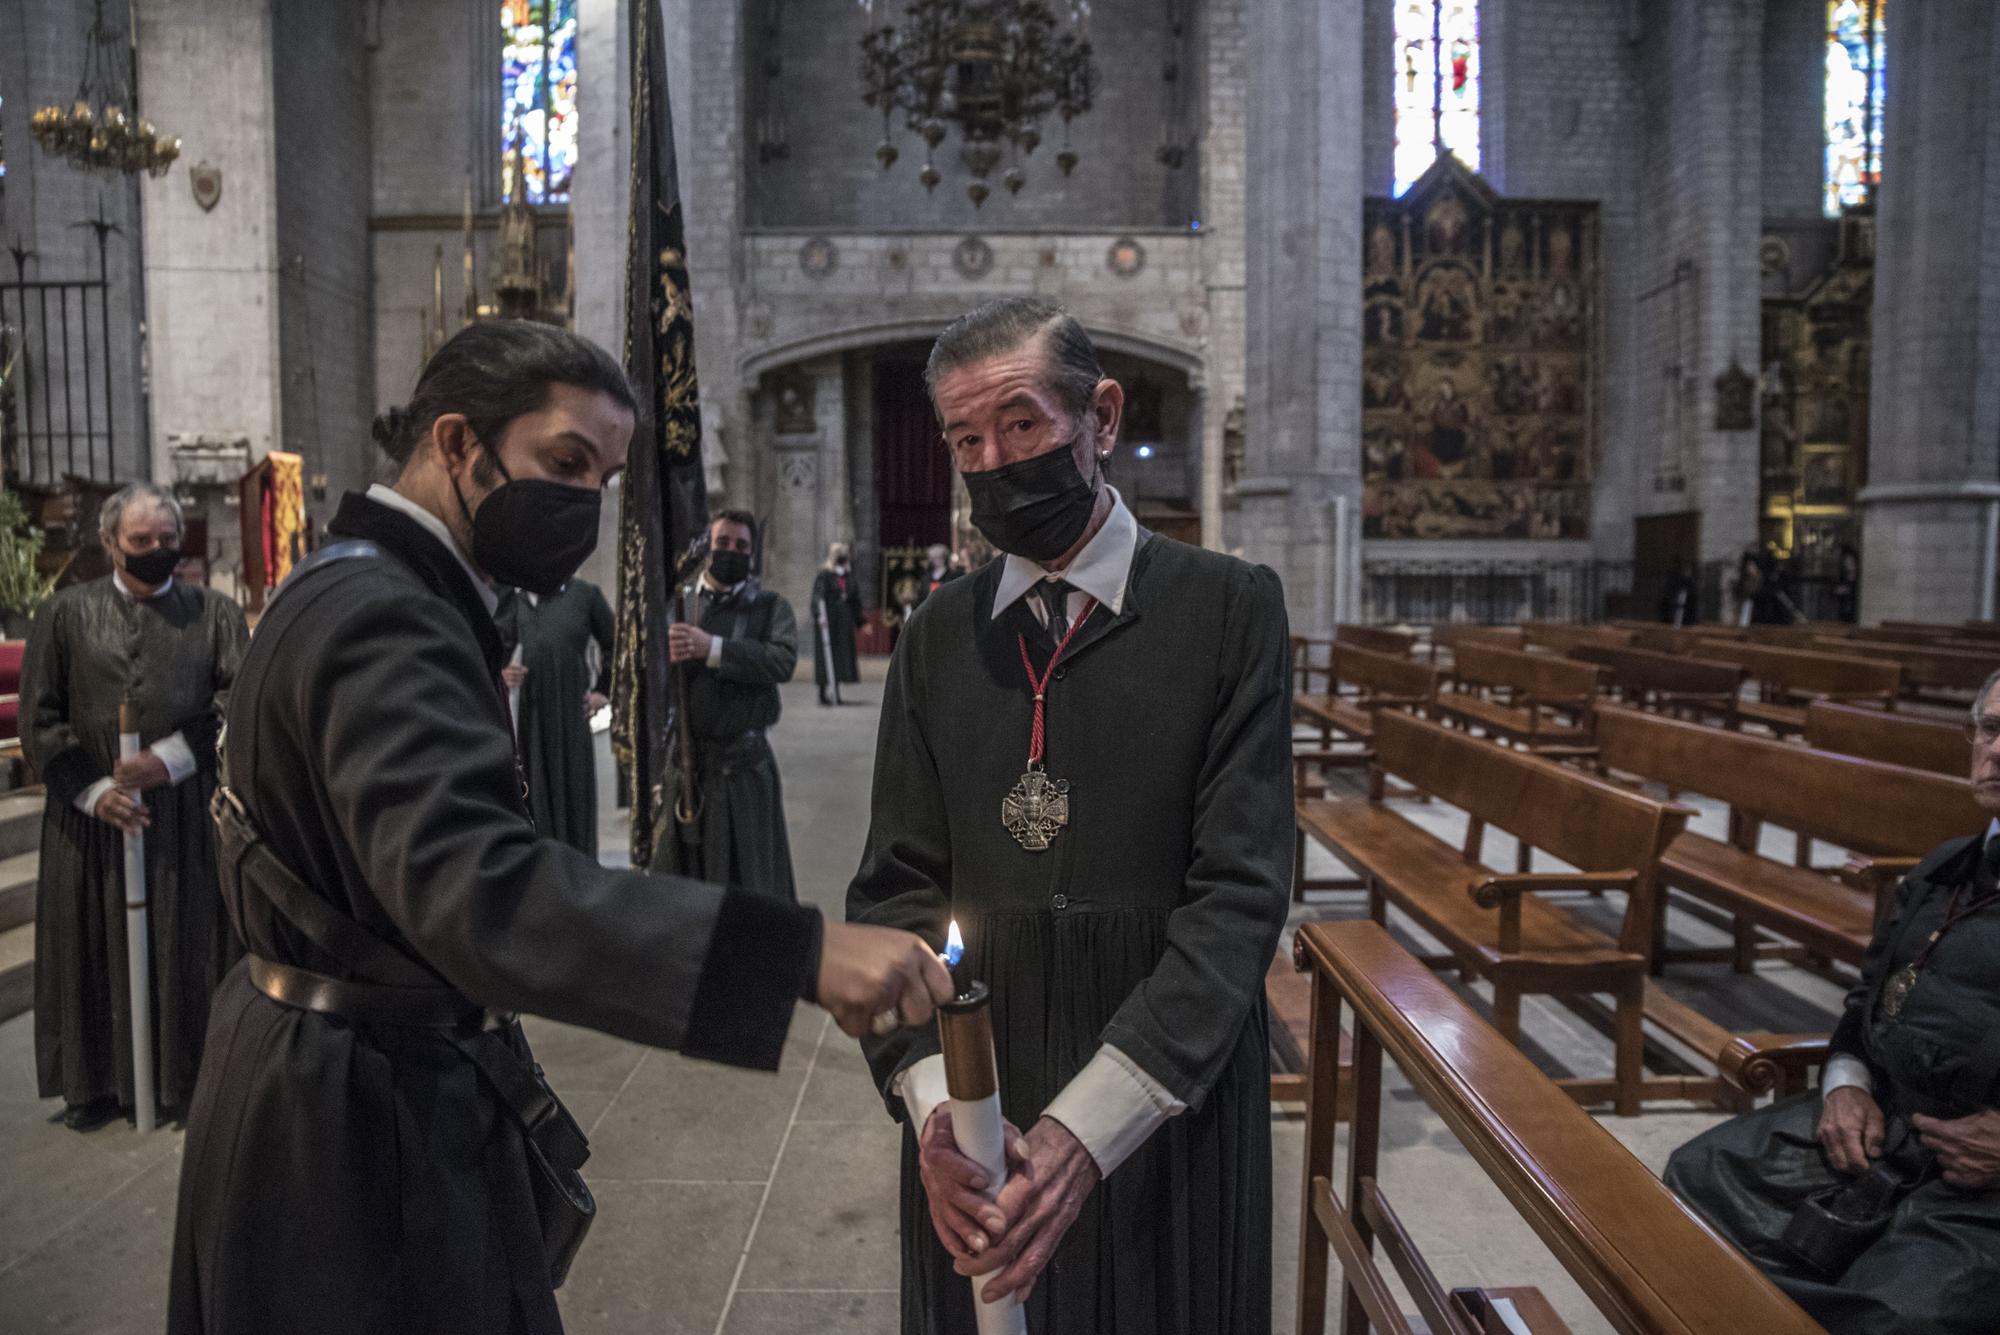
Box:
1860;0;2000;622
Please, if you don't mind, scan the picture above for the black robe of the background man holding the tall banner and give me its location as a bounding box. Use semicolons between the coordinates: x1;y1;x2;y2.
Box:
654;580;798;901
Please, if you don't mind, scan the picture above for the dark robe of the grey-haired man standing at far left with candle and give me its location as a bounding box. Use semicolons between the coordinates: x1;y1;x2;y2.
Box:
22;576;248;1113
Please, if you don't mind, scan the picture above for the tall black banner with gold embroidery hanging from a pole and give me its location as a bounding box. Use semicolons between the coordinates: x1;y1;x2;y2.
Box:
612;0;708;867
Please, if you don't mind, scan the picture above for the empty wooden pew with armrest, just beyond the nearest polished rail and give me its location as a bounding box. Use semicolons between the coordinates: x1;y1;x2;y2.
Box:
1296;711;1690;1117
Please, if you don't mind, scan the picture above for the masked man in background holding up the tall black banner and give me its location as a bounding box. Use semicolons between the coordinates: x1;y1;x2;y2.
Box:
660;510;798;901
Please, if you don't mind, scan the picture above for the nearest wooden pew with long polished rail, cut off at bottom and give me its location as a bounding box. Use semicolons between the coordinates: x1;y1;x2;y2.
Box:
1296;923;1824;1335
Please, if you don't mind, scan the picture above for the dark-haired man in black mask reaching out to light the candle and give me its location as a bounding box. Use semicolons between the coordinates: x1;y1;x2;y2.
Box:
166;320;950;1335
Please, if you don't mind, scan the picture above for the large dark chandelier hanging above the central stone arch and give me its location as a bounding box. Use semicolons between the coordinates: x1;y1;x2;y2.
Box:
862;0;1098;208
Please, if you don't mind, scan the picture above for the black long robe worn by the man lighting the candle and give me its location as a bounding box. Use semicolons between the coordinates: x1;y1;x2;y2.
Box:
168;496;818;1335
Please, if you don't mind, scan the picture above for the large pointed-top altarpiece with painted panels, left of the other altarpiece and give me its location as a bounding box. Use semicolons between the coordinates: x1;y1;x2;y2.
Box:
1362;156;1598;538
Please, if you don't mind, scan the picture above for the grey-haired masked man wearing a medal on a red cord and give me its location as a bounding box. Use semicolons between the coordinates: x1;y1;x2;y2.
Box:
848;298;1292;1335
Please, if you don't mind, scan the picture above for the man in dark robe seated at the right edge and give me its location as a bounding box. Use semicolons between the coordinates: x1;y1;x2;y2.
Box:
1666;673;2000;1335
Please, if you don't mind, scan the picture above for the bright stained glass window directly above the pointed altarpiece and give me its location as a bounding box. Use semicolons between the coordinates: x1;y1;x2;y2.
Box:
1396;0;1480;194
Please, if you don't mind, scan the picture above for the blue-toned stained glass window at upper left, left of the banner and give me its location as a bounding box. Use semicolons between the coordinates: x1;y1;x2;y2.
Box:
500;0;576;204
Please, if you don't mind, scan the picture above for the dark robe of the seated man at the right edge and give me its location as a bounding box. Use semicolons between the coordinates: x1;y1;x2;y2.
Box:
1666;839;2000;1335
